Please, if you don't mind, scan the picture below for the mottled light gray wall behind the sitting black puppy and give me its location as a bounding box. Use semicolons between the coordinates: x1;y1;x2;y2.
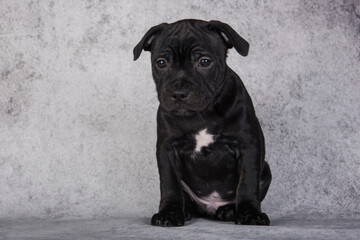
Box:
0;0;360;218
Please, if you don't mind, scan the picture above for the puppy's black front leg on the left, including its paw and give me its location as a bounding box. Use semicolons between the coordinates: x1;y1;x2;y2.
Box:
151;141;185;227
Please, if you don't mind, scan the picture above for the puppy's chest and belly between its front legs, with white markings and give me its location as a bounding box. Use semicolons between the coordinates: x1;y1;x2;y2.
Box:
180;127;237;215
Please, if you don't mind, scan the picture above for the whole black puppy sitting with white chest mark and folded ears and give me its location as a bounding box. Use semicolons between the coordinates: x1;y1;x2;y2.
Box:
134;19;271;226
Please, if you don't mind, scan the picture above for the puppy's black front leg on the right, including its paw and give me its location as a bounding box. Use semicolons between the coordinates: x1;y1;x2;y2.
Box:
234;136;270;225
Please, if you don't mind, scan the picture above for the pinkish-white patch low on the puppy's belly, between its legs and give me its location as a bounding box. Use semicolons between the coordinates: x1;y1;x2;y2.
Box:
181;180;234;216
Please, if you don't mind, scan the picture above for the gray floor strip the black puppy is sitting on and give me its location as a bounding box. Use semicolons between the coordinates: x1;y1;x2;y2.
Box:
0;217;360;240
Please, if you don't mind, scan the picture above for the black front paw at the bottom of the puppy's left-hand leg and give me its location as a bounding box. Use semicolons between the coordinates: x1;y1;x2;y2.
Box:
151;211;185;227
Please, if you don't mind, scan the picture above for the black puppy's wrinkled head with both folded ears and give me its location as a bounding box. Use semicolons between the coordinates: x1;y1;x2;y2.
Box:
134;19;249;116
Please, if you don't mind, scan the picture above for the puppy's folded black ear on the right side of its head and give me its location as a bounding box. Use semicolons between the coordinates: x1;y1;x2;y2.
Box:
208;21;249;57
